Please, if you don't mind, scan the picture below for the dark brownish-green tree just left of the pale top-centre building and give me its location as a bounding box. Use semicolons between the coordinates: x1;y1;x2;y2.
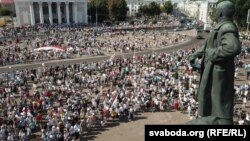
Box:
108;0;128;21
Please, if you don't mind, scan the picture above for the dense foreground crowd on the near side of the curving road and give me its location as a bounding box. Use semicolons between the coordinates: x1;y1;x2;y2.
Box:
0;39;249;141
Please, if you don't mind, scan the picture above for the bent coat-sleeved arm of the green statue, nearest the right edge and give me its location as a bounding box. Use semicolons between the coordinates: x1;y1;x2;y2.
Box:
208;32;241;62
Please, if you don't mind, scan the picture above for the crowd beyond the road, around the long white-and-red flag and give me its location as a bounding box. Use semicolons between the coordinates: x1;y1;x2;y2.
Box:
0;18;188;66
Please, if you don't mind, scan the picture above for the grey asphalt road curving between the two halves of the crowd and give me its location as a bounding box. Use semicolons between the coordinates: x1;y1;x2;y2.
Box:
0;32;206;73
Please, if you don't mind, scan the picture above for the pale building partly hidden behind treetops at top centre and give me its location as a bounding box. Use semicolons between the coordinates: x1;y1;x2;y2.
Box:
126;0;170;16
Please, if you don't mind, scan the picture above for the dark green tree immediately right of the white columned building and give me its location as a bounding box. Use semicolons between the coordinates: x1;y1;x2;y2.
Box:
88;0;108;22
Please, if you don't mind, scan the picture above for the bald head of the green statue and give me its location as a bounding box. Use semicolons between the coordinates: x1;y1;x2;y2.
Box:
216;1;235;22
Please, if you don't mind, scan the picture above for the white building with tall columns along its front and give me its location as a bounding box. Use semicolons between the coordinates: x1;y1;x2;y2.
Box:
14;0;88;25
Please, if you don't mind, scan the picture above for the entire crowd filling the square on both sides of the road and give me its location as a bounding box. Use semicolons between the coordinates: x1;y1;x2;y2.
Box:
0;14;250;141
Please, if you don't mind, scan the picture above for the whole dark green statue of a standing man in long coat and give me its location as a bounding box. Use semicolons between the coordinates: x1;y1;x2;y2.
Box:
186;1;241;125
